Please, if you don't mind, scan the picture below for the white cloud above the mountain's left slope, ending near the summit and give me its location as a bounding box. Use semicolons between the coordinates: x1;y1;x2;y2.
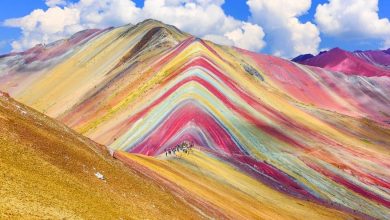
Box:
3;0;140;51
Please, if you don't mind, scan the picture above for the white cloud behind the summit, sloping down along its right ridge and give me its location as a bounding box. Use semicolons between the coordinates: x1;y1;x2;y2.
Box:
143;0;264;51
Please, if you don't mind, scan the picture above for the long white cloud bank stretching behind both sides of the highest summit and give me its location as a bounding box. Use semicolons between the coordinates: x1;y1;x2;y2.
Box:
4;0;264;51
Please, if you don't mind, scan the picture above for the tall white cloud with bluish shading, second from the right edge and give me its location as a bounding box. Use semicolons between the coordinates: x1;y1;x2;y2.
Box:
247;0;321;57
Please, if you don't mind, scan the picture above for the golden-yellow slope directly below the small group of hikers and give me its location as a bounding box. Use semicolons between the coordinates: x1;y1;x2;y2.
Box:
115;150;358;219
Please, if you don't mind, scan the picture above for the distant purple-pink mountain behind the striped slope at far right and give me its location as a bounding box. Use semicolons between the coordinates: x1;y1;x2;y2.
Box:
292;48;390;76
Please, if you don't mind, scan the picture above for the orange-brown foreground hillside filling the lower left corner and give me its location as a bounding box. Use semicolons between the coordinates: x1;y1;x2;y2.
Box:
0;92;201;219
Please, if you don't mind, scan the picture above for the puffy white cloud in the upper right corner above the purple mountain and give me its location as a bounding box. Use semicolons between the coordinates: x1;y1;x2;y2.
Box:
315;0;390;46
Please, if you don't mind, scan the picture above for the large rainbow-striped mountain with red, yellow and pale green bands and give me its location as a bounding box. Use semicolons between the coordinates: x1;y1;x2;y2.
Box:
0;20;390;219
